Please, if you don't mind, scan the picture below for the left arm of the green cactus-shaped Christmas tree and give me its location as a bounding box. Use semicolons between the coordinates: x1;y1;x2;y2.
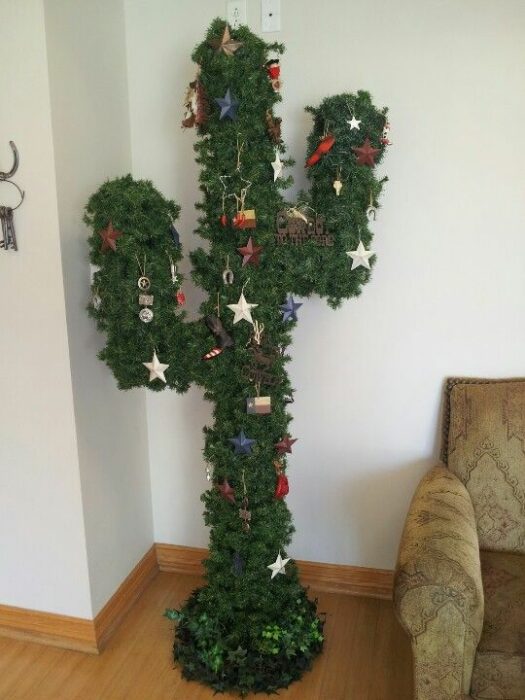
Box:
84;175;191;391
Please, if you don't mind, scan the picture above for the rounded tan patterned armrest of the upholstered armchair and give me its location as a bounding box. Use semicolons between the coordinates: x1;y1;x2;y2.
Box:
394;466;483;700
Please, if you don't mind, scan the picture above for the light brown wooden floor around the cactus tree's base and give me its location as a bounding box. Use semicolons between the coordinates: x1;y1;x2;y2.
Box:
0;573;412;700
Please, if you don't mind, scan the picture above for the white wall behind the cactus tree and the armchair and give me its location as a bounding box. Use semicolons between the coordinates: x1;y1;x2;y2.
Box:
125;0;525;567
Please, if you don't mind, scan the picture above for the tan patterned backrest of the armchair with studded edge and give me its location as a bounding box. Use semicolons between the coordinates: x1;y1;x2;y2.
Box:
442;379;525;553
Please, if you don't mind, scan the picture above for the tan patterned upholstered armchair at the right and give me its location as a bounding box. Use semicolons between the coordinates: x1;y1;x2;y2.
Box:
394;379;525;700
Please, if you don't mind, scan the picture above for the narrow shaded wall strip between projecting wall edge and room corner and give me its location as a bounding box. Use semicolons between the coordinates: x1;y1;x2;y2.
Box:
44;0;153;614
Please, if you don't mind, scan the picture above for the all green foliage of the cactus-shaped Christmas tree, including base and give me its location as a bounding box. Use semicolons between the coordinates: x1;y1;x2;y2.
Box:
87;19;386;695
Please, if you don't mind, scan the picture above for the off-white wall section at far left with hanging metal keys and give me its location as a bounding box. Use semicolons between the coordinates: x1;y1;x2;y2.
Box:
0;0;91;617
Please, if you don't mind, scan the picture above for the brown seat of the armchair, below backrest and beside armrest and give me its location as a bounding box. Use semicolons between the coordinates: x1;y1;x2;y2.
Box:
472;551;525;700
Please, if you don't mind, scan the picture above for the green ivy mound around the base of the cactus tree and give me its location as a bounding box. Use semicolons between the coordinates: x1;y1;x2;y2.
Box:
166;584;324;697
